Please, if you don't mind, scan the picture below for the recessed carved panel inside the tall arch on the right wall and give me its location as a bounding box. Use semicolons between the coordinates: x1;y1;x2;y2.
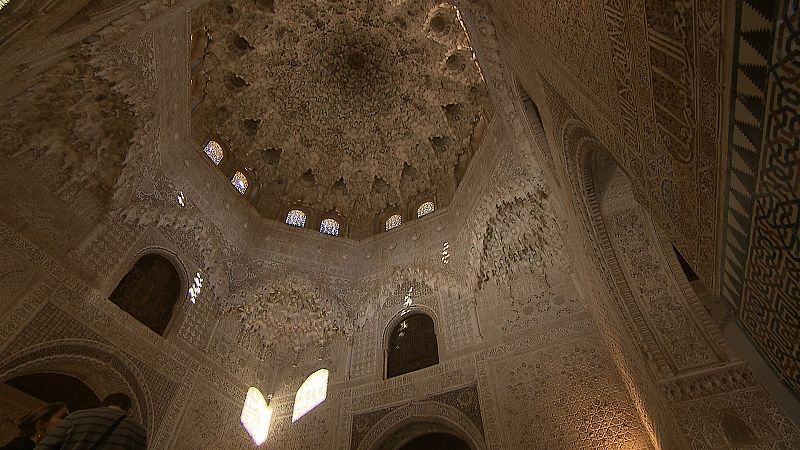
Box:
581;133;726;377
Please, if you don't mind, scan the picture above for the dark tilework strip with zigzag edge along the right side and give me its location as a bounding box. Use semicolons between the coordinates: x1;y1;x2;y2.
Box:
720;0;800;400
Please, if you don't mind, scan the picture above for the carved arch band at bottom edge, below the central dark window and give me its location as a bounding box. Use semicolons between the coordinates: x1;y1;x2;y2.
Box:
354;401;486;450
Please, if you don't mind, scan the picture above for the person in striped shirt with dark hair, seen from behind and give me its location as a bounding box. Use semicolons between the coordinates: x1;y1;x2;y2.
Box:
36;394;147;450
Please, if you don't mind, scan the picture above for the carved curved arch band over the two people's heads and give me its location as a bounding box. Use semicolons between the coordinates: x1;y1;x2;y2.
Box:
0;339;154;433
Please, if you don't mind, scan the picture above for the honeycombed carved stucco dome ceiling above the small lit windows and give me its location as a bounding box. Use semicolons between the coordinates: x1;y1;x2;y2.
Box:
192;0;488;234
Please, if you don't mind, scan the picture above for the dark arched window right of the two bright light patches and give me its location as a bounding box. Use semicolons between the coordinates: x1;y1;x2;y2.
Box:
386;314;439;378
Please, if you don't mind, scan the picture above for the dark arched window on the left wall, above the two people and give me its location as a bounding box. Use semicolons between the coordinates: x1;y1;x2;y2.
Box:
109;255;181;334
